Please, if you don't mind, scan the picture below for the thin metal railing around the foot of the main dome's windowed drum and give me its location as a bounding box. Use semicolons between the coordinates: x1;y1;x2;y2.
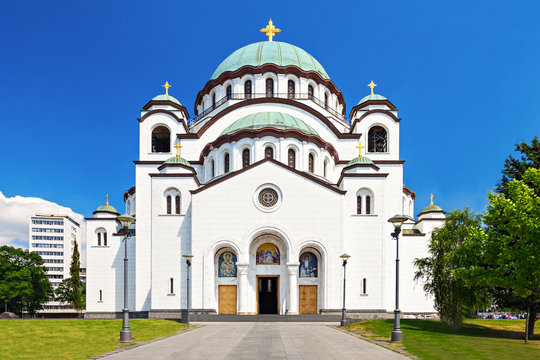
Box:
188;93;350;126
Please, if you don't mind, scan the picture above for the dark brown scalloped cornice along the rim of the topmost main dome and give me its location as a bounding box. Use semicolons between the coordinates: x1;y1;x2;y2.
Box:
194;64;347;116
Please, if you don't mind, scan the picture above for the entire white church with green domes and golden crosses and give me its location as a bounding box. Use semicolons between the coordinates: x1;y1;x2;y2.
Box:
86;22;445;318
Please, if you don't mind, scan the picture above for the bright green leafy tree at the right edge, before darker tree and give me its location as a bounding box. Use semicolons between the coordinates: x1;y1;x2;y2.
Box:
484;167;540;340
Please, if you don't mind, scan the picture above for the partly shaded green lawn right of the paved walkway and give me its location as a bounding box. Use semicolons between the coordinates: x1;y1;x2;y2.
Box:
345;320;540;360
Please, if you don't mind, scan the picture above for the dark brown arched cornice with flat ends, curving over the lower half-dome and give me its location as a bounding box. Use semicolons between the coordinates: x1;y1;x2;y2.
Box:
180;97;362;140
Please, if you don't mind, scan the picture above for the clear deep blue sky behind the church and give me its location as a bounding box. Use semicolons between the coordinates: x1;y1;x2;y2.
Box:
0;0;540;221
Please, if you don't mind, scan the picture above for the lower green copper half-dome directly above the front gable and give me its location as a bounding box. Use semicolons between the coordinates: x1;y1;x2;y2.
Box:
220;112;319;136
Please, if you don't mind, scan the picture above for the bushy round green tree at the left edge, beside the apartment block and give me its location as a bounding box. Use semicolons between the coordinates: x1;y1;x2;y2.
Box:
0;246;53;316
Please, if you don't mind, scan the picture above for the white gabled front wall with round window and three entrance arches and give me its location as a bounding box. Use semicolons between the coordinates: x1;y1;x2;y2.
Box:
192;162;342;313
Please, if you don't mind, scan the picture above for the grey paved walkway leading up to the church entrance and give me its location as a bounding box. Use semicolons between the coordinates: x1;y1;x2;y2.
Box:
101;322;407;360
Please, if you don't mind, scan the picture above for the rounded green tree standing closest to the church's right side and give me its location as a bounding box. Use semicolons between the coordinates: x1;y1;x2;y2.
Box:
414;209;487;328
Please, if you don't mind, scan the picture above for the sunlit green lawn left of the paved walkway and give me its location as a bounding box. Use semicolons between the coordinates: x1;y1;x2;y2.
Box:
0;319;185;360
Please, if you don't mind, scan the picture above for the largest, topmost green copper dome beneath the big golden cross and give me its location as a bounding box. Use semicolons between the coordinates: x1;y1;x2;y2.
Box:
212;41;330;80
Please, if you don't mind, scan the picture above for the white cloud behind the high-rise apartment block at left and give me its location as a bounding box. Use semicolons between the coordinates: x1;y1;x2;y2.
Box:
0;191;86;262
